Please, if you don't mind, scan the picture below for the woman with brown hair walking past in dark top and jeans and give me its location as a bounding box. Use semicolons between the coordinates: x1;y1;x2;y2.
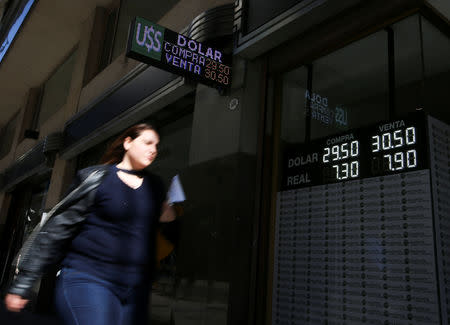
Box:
5;124;175;325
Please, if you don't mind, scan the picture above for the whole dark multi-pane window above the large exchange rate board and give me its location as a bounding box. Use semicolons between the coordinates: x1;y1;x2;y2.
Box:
281;15;450;148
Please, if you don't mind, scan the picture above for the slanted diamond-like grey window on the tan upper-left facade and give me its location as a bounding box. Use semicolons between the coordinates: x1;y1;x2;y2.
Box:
38;51;77;125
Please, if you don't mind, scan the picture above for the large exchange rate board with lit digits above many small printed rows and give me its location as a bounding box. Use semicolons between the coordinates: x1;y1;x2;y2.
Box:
272;115;450;325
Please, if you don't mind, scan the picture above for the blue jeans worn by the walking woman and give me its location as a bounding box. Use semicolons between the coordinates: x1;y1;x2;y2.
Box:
55;268;149;325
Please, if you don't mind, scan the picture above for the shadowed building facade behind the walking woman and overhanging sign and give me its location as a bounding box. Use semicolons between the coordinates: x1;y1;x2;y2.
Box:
0;0;450;324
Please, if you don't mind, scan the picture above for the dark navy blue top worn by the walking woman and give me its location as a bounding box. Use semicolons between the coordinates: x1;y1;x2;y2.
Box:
62;166;165;286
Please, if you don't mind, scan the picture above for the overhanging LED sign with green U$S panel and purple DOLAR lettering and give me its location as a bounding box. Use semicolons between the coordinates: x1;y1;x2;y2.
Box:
126;17;231;89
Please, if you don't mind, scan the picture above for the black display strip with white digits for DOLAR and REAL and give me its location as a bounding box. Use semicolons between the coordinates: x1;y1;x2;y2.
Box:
281;113;428;190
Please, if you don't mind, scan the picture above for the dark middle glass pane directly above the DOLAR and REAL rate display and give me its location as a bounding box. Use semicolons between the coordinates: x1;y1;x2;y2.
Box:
308;31;389;139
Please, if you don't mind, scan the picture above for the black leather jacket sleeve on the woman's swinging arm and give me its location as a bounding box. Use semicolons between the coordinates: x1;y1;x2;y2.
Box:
8;165;110;298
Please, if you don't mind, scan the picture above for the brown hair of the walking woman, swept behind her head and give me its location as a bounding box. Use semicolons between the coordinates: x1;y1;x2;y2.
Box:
100;123;158;164
